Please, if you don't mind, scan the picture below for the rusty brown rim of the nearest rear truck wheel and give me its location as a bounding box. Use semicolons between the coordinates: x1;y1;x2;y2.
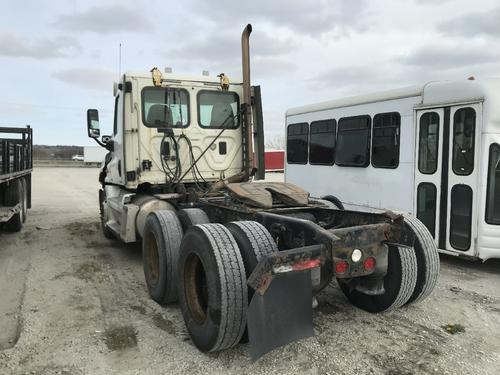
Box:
184;254;208;324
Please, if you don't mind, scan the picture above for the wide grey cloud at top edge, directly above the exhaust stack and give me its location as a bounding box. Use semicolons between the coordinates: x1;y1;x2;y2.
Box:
186;0;368;35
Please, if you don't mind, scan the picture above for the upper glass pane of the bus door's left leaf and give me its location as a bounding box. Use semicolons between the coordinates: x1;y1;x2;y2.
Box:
418;112;439;174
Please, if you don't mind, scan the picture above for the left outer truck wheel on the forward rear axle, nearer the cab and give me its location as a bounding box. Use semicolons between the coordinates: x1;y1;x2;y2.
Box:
142;210;182;305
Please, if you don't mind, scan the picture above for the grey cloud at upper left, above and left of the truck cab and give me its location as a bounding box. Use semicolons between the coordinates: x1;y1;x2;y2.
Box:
54;4;153;34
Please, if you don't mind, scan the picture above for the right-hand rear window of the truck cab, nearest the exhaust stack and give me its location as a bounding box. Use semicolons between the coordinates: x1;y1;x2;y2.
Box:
198;90;239;129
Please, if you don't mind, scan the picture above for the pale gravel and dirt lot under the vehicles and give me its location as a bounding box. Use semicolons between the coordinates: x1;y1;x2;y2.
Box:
0;168;500;375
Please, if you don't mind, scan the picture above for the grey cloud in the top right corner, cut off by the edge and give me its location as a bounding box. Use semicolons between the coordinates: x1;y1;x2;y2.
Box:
439;7;500;37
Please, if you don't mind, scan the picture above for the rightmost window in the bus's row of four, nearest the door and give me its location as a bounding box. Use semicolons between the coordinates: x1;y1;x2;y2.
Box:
372;112;401;168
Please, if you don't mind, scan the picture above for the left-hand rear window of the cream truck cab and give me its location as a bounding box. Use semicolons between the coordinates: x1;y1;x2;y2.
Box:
142;87;189;128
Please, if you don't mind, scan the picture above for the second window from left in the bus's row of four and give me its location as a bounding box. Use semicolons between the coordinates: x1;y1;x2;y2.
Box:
309;120;337;165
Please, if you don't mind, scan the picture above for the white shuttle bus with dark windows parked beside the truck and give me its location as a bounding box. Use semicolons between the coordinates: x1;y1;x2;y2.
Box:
285;79;500;261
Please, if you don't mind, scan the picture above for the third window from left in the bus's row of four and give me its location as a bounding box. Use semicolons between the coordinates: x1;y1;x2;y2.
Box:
335;116;371;167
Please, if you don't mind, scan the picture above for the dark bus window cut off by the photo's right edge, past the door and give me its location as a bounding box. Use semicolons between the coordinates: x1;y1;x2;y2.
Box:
486;143;500;225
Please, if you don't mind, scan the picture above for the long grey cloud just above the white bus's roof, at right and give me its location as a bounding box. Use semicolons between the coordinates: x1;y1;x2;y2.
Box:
399;43;499;69
